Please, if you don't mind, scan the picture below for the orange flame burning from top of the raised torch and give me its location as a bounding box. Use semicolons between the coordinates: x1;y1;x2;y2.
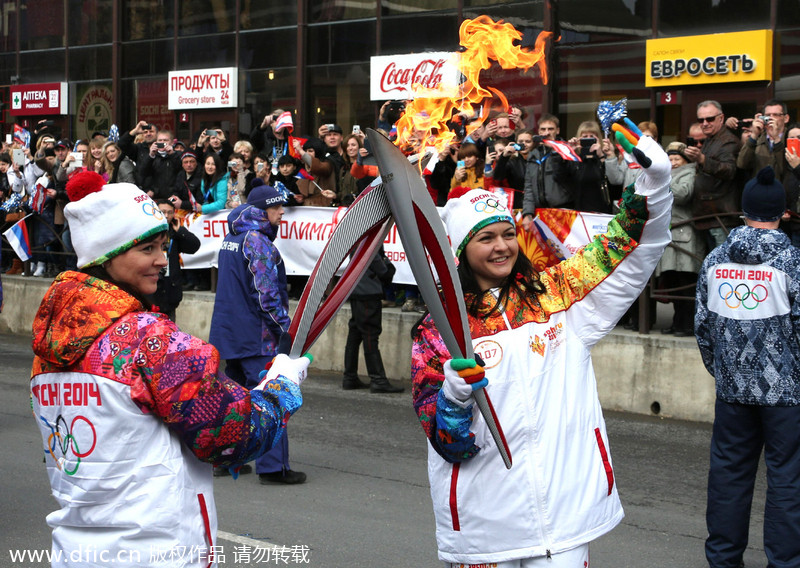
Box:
396;16;552;158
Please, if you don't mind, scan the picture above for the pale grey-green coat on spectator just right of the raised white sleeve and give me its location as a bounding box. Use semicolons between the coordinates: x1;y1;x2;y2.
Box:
656;164;705;275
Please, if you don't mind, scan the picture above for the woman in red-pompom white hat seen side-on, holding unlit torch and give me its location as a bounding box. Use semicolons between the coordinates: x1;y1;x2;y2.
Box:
31;172;309;566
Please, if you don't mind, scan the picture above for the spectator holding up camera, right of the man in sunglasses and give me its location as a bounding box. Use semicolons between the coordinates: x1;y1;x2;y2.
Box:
726;99;789;180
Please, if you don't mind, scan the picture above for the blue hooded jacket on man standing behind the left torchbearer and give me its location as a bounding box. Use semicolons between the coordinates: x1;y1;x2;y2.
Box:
209;205;290;359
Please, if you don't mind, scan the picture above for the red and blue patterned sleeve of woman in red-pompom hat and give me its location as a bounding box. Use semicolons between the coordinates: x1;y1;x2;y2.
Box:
126;313;302;466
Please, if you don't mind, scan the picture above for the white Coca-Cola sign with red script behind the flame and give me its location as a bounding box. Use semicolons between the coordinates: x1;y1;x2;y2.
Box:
370;52;459;101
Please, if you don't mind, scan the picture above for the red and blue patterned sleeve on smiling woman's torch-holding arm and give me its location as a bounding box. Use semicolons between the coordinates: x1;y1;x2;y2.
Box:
411;316;480;462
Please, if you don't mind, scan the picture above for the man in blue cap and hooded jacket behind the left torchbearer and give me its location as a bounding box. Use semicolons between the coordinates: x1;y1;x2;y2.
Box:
209;178;306;484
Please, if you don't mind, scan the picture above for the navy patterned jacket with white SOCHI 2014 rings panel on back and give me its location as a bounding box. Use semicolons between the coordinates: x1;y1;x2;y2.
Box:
694;226;800;406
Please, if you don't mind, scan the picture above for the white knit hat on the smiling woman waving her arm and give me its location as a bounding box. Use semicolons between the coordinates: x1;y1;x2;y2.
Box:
442;189;514;256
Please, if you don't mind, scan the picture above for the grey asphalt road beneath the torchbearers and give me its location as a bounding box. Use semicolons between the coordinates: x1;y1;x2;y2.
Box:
0;335;766;568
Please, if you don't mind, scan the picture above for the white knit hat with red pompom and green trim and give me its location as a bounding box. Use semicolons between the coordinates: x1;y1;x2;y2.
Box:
64;172;168;268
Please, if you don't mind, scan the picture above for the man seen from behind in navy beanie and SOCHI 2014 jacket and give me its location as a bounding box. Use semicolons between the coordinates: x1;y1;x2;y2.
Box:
695;167;800;568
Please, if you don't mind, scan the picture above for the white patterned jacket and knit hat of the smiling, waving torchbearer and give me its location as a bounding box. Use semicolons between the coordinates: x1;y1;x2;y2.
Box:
412;137;672;566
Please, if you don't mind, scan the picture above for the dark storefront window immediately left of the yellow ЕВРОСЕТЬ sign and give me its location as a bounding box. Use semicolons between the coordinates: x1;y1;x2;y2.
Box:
552;42;652;137
